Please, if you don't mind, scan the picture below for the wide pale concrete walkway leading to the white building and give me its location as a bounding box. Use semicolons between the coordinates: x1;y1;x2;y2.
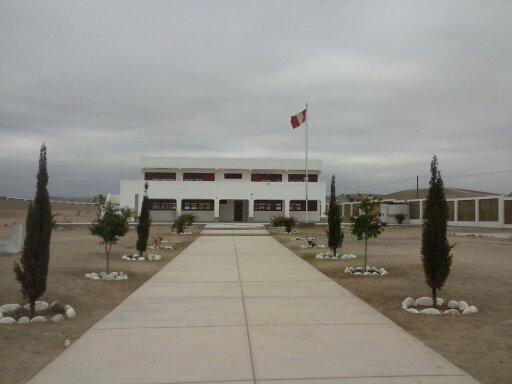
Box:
30;236;476;384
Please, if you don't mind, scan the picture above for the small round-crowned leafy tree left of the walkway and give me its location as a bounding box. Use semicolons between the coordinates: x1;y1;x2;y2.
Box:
90;202;129;273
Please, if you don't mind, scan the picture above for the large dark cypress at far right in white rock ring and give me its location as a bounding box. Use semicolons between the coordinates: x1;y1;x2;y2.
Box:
421;156;452;307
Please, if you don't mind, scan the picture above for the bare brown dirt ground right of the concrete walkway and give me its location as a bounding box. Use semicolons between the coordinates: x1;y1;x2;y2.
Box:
273;227;512;384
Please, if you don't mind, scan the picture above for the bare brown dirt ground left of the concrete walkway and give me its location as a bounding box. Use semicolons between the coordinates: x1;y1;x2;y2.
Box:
0;224;198;384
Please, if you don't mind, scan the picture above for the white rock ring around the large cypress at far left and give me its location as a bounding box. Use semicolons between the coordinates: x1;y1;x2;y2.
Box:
0;300;76;324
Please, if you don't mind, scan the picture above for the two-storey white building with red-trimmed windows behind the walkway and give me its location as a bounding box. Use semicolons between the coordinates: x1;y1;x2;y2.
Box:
119;157;325;222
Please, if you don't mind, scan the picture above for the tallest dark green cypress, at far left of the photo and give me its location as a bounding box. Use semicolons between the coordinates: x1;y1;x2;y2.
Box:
14;144;53;316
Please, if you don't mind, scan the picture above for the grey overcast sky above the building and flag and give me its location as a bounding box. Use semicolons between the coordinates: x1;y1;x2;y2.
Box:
0;0;512;197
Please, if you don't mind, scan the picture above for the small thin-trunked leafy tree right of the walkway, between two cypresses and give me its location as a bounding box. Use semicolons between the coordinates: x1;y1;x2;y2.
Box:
350;198;384;269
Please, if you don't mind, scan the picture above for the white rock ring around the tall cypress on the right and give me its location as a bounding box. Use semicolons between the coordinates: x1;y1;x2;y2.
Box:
402;296;478;315
